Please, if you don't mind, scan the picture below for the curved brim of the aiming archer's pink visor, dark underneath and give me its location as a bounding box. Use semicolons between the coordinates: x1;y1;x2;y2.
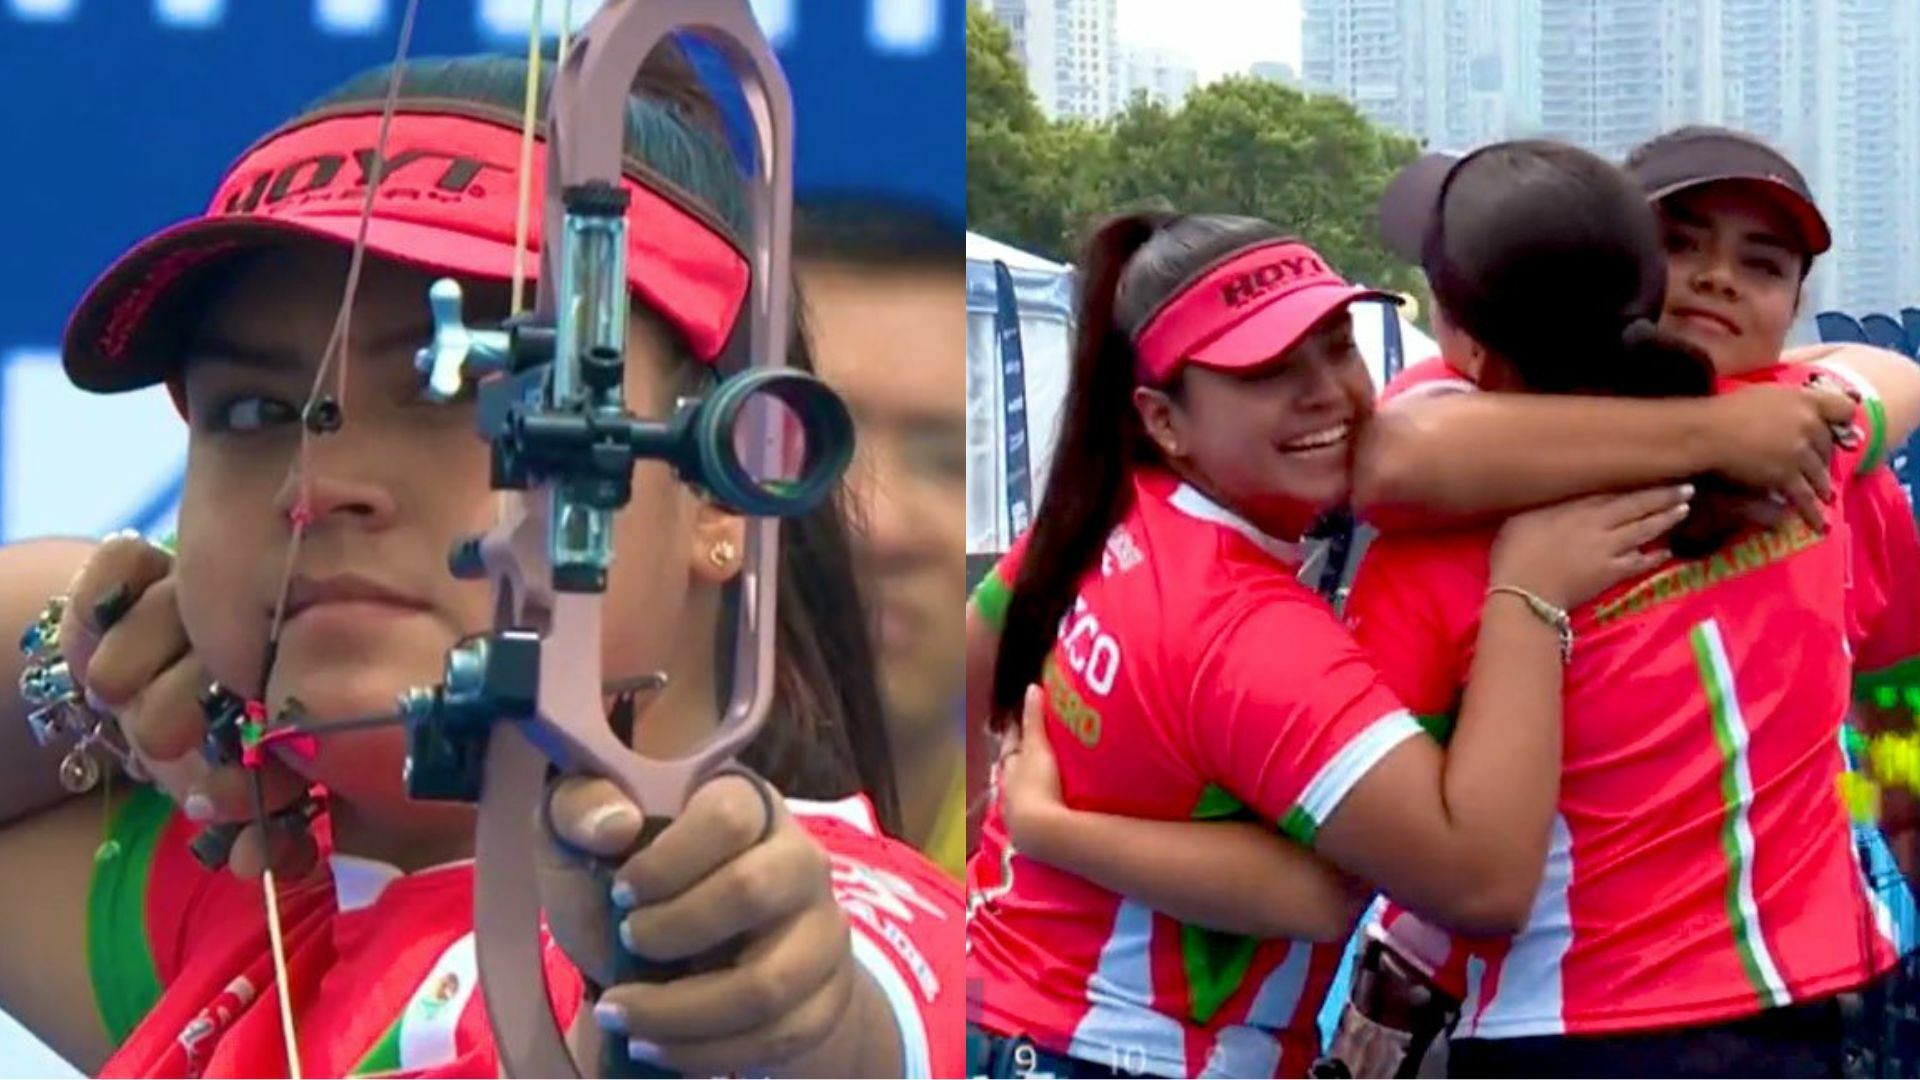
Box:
61;215;540;394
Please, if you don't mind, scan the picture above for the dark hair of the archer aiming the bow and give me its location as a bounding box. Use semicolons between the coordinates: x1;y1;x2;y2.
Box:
309;48;900;834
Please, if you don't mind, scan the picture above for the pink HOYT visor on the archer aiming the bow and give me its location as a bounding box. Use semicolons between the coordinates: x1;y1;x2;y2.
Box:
63;102;751;392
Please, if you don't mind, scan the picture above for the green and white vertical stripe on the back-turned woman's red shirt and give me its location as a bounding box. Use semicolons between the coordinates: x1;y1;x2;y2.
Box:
1690;619;1791;1009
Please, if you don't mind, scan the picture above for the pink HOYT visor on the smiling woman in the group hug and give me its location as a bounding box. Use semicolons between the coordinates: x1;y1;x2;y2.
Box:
1133;240;1400;384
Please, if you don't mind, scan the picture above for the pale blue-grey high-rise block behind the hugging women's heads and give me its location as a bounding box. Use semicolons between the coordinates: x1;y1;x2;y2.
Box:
1302;0;1920;315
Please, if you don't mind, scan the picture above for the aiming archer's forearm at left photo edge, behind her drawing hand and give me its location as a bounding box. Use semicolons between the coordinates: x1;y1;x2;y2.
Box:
0;540;94;826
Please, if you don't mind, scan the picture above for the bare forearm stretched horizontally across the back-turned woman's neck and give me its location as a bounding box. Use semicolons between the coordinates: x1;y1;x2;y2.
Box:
1354;392;1713;528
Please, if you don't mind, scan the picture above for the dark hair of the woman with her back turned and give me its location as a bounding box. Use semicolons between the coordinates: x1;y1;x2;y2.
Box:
1425;140;1740;555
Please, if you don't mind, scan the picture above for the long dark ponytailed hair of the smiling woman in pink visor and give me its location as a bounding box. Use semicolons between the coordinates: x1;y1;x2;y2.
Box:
991;211;1284;730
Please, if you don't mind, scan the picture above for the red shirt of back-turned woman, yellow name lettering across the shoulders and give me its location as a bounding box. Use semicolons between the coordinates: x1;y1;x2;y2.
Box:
1348;353;1920;1038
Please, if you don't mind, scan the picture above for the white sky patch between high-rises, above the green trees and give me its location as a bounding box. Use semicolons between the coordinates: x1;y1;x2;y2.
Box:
1119;0;1300;83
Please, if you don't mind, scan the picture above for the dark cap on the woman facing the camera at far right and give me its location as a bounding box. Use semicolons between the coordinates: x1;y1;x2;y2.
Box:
1626;127;1834;258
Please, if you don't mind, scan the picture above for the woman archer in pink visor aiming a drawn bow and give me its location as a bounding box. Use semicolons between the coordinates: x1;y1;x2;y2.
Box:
0;42;962;1076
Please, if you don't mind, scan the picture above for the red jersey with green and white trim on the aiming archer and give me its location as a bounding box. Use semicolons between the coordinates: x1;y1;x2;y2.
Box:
88;776;964;1076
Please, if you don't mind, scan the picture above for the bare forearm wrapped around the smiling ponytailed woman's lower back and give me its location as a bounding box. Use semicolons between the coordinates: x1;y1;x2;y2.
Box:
1020;805;1367;942
